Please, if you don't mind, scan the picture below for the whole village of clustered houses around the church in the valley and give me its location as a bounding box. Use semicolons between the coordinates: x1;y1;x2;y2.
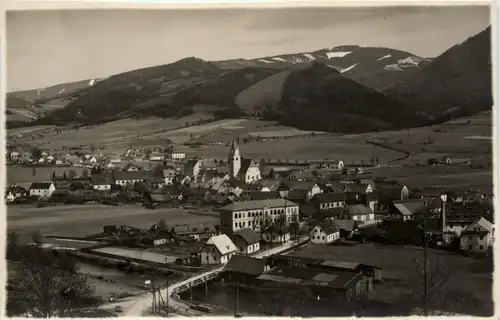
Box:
5;138;495;315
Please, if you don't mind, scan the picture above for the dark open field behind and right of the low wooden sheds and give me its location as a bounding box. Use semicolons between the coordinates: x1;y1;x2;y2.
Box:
289;243;493;304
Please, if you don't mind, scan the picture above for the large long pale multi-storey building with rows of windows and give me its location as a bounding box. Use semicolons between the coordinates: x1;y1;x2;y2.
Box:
219;199;299;233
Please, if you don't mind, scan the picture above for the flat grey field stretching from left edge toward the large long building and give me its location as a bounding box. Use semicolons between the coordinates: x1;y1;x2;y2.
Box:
7;204;217;237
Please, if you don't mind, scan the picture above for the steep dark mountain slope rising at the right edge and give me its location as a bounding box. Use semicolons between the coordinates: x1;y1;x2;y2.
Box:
384;28;493;118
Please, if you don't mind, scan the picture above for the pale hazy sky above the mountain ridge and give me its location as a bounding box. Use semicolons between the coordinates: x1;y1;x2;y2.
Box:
6;6;490;92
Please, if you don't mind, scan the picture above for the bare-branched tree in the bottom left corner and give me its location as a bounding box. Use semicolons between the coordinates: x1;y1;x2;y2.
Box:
7;237;102;318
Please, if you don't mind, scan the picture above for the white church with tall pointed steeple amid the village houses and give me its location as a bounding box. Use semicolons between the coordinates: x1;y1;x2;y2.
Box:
227;140;262;183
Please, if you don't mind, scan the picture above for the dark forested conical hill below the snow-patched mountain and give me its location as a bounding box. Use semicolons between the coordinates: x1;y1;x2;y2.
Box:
263;62;428;133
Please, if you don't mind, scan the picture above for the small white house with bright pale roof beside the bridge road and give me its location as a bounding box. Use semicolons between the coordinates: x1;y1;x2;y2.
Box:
200;234;238;264
